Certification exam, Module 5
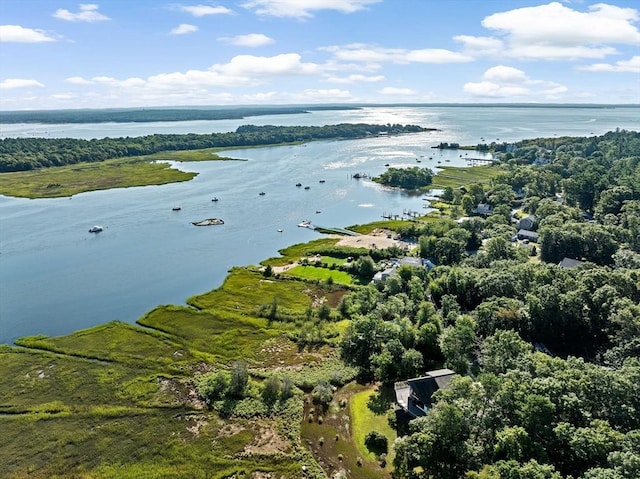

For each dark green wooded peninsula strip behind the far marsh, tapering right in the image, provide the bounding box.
[0,123,427,172]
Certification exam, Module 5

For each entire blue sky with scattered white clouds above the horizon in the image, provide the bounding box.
[0,0,640,110]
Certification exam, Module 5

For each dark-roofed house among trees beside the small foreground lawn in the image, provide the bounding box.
[394,369,456,420]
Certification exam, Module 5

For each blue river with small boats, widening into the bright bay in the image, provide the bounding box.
[0,107,640,343]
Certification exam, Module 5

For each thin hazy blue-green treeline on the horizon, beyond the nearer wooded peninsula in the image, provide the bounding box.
[0,106,356,124]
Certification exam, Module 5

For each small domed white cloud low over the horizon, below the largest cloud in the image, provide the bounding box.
[464,65,568,100]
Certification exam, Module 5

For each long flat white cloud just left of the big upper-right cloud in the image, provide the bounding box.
[321,43,473,65]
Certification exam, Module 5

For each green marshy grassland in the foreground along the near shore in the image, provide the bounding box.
[0,218,408,479]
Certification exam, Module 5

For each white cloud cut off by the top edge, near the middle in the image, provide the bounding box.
[242,0,382,19]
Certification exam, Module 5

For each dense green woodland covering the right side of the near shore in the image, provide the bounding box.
[339,131,640,479]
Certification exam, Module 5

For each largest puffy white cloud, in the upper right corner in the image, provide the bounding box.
[482,2,640,59]
